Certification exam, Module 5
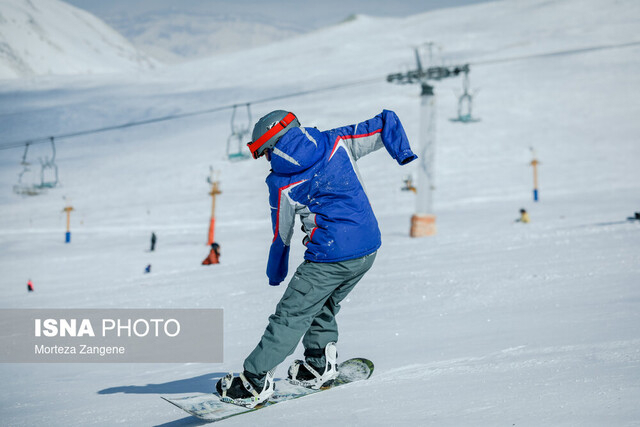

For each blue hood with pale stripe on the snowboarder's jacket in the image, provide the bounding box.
[271,127,324,175]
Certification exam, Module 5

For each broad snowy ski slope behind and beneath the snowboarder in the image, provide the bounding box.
[0,0,640,426]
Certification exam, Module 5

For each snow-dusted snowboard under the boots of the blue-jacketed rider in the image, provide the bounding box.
[162,358,373,422]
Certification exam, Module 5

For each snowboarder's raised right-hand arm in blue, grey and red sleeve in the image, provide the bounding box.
[327,110,418,165]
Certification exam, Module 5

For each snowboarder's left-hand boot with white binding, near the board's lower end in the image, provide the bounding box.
[216,369,275,408]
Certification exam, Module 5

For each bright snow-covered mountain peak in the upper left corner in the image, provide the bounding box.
[0,0,155,79]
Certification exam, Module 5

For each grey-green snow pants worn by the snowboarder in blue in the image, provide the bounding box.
[244,252,376,379]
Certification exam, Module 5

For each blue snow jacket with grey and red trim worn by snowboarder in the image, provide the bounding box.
[266,110,417,286]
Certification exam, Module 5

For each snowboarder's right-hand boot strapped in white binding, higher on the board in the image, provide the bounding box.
[288,342,338,390]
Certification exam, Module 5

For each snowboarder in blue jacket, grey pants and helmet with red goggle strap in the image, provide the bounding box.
[216,110,417,407]
